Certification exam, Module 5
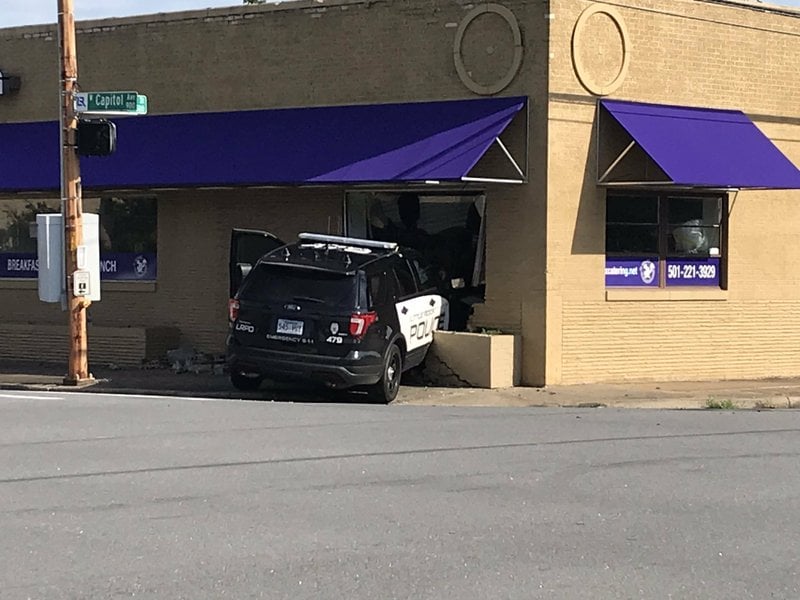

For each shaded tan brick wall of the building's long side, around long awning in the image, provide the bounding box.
[0,0,547,372]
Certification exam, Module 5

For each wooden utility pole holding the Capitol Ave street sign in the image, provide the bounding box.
[58,0,92,385]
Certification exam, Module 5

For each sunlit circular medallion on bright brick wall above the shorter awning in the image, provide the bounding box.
[572,4,631,96]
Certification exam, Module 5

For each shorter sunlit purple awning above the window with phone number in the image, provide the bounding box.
[600,100,800,189]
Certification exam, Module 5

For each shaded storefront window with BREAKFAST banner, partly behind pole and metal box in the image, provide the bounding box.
[0,197,158,281]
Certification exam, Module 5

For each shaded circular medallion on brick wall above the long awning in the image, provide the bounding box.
[453,4,522,96]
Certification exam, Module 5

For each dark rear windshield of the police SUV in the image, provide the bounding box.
[239,264,358,310]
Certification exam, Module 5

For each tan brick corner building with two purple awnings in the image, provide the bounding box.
[0,0,800,385]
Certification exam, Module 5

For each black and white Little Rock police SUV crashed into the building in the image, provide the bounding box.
[227,230,448,402]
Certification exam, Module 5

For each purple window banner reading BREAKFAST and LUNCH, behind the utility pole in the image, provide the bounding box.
[0,252,157,281]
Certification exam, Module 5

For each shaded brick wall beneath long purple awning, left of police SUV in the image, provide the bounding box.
[0,188,344,363]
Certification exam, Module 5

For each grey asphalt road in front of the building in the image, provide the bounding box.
[0,392,800,600]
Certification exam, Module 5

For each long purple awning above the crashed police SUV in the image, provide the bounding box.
[0,97,526,191]
